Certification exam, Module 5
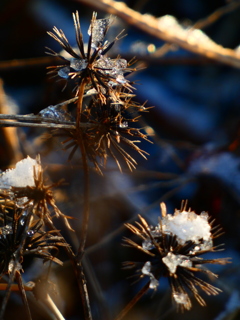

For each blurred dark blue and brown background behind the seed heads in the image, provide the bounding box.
[0,0,240,320]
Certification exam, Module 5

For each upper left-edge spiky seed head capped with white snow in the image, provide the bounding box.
[0,156,71,229]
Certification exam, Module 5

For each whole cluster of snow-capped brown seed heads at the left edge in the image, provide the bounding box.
[0,156,69,314]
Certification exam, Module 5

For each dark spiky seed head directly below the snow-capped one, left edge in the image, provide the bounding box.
[0,208,65,277]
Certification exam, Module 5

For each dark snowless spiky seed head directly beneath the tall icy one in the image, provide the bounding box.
[53,98,149,174]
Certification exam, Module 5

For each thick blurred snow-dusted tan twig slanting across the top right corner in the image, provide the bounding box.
[78,0,240,68]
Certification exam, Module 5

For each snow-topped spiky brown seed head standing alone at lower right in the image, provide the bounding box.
[124,205,229,311]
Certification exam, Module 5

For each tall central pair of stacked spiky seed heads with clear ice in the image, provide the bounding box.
[45,12,148,174]
